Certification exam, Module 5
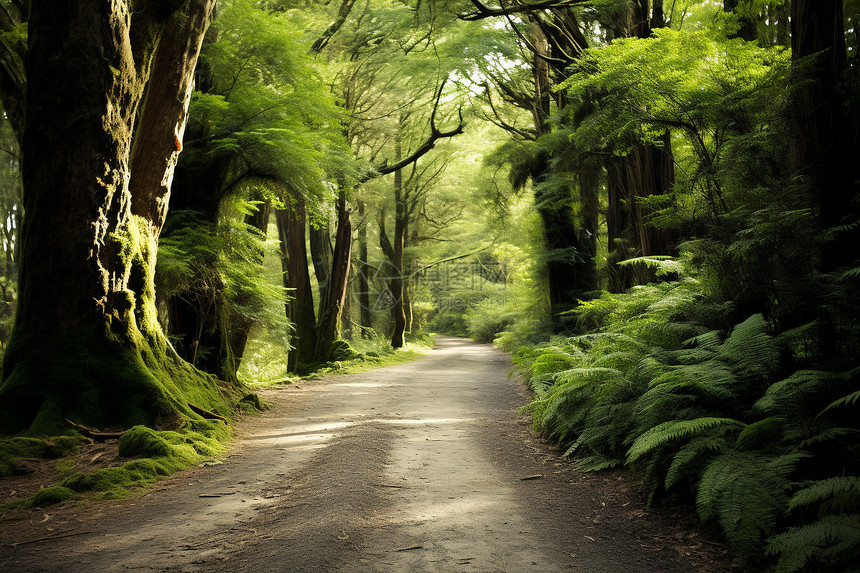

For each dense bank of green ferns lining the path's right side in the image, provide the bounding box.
[514,279,860,572]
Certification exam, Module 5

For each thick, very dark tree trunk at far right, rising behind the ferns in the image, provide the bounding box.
[781,0,860,358]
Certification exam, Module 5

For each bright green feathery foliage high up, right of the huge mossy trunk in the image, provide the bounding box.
[188,0,353,204]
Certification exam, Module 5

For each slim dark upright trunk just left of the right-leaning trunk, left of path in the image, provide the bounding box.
[275,197,316,372]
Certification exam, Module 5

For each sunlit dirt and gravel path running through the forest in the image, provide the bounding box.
[0,337,727,573]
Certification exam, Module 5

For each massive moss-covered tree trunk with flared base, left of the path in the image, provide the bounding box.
[0,0,226,433]
